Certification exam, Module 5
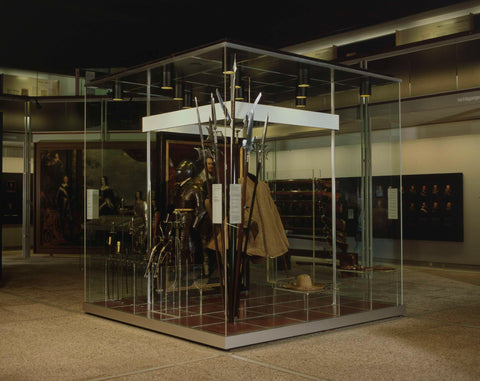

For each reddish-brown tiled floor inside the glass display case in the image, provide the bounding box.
[89,287,394,335]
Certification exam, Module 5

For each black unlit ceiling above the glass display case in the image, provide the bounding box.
[0,0,470,75]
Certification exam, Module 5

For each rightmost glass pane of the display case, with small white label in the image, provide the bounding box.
[335,78,402,309]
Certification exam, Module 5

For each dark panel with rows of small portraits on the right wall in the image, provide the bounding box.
[337,173,463,242]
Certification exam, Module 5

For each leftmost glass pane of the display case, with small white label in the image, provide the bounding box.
[85,96,148,314]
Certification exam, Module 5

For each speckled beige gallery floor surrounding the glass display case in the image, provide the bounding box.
[0,252,480,381]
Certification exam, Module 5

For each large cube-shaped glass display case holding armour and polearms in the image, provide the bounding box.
[84,41,405,349]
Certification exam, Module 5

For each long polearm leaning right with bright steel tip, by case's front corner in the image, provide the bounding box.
[232,93,262,316]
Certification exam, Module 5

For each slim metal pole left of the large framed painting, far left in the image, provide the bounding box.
[22,100,32,259]
